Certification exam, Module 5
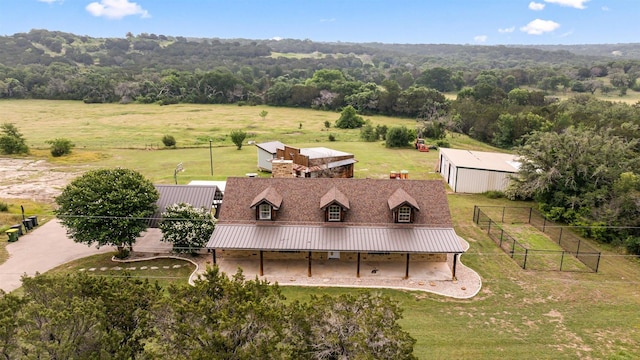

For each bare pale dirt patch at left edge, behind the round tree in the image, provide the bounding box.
[0,158,85,203]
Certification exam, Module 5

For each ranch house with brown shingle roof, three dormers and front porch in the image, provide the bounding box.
[206,178,464,279]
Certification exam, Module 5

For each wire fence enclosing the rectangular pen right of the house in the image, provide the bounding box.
[473,205,601,272]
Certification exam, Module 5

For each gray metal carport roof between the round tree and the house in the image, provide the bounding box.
[149,185,218,228]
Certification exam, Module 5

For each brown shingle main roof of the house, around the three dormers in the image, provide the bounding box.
[218,177,453,228]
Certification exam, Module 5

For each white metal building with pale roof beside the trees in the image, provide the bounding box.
[437,148,520,193]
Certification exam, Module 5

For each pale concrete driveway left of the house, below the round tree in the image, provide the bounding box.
[0,219,114,292]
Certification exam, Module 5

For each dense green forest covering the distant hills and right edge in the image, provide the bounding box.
[0,30,640,254]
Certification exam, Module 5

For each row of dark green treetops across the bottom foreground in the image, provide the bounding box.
[0,268,415,359]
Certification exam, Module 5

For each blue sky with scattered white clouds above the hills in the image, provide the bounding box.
[0,0,640,45]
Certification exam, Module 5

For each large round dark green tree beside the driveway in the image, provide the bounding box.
[56,168,159,250]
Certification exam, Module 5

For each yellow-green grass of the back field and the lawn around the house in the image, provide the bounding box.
[0,101,640,359]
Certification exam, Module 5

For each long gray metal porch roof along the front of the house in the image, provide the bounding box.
[206,224,464,253]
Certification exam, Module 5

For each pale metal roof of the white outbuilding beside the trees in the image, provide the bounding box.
[440,148,520,173]
